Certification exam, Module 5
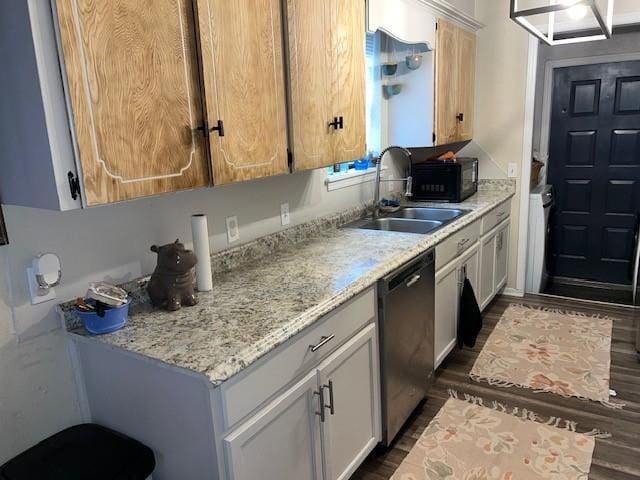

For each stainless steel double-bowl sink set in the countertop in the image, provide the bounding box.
[347,207,467,235]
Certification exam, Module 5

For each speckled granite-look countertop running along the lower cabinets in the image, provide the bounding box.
[61,182,514,385]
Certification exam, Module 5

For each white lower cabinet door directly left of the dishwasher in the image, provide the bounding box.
[318,324,380,480]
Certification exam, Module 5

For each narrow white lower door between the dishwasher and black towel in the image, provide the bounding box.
[434,261,460,368]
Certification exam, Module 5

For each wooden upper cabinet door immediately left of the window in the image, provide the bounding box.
[330,0,366,163]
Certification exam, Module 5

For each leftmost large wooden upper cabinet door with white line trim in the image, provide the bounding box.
[55,0,209,205]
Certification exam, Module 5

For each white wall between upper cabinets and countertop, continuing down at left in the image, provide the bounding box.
[0,165,394,463]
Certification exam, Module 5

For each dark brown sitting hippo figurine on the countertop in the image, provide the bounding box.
[147,240,198,312]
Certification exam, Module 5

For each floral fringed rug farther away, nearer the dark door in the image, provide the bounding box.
[469,305,621,408]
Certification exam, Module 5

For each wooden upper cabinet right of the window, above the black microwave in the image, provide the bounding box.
[435,19,476,145]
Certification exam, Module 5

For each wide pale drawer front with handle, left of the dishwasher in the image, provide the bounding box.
[221,288,375,429]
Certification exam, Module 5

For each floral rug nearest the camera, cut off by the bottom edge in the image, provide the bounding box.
[391,398,597,480]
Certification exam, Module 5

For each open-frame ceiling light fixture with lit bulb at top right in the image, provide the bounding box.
[510,0,614,45]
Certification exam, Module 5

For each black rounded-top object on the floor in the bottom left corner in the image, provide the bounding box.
[0,423,156,480]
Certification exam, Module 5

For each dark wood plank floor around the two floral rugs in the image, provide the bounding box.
[352,296,640,480]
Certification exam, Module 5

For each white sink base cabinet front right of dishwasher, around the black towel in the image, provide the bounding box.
[434,242,479,368]
